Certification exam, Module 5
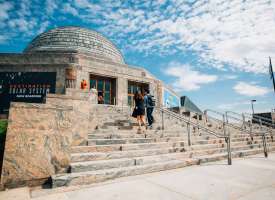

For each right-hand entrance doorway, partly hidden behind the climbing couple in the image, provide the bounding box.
[128,81,149,107]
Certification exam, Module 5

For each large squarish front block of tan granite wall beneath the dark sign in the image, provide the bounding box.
[1,103,73,187]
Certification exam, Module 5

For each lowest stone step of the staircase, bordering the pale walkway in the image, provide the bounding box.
[52,148,275,187]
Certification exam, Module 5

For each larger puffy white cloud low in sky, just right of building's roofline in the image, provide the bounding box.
[165,62,218,91]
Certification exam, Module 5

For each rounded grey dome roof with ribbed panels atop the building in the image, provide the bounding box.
[24,27,124,64]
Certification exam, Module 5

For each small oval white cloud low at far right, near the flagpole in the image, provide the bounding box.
[233,82,269,97]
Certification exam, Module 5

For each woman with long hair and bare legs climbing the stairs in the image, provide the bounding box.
[132,91,146,131]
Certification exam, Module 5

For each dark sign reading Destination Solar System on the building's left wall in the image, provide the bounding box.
[0,72,56,113]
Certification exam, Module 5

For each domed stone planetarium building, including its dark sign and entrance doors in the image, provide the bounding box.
[0,27,180,113]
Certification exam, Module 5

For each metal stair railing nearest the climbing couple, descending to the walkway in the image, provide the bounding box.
[155,107,232,165]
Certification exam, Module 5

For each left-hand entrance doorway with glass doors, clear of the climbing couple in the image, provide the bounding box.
[90,74,116,105]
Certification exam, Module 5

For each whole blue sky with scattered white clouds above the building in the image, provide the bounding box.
[0,0,275,112]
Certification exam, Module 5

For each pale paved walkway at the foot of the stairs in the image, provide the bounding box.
[0,153,275,200]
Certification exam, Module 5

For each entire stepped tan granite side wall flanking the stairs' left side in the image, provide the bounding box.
[0,89,139,187]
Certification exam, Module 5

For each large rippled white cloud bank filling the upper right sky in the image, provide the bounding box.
[68,0,275,73]
